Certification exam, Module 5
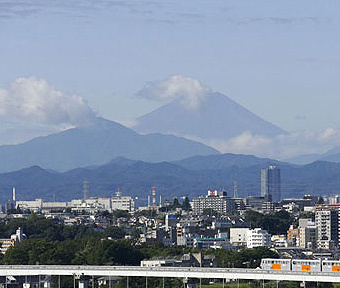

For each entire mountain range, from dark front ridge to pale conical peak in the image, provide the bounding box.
[0,84,340,204]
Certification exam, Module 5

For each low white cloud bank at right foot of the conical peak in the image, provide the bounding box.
[205,128,340,159]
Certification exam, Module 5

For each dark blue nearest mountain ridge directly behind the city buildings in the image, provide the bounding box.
[0,154,340,205]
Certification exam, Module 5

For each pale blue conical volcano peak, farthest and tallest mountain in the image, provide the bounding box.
[134,92,287,142]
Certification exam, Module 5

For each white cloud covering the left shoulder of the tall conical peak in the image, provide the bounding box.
[137,75,211,109]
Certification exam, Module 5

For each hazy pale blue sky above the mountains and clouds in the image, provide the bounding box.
[0,0,340,158]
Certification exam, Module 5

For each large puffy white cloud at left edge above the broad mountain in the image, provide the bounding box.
[0,77,95,127]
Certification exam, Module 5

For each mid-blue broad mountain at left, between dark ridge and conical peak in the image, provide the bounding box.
[0,118,219,172]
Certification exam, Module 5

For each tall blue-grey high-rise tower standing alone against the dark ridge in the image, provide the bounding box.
[261,166,281,202]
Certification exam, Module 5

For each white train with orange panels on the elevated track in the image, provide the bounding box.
[261,258,340,273]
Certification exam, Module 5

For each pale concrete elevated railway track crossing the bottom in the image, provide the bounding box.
[0,265,340,283]
